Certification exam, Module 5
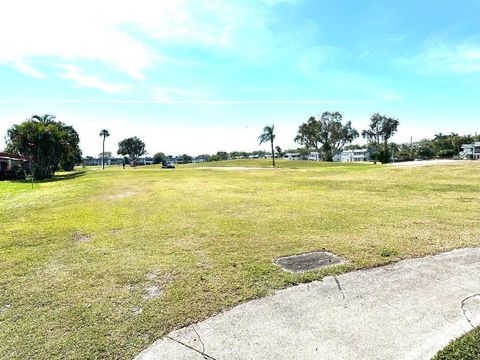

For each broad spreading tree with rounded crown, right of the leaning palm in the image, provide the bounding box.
[295,111,358,161]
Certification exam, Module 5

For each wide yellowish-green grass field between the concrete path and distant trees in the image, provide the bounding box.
[0,160,480,359]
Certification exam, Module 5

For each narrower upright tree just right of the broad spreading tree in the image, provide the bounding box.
[362,113,399,163]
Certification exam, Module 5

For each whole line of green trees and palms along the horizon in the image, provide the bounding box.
[2,111,480,179]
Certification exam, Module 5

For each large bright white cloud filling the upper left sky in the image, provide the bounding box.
[0,0,219,80]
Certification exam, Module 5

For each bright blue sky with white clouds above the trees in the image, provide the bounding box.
[0,0,480,155]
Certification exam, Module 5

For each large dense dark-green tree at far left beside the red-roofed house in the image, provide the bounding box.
[6,114,82,180]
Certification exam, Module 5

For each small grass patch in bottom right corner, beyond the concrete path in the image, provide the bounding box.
[433,327,480,360]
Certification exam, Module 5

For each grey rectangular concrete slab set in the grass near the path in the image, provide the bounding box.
[273,251,342,272]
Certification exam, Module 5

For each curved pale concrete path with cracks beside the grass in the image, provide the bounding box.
[137,249,480,360]
